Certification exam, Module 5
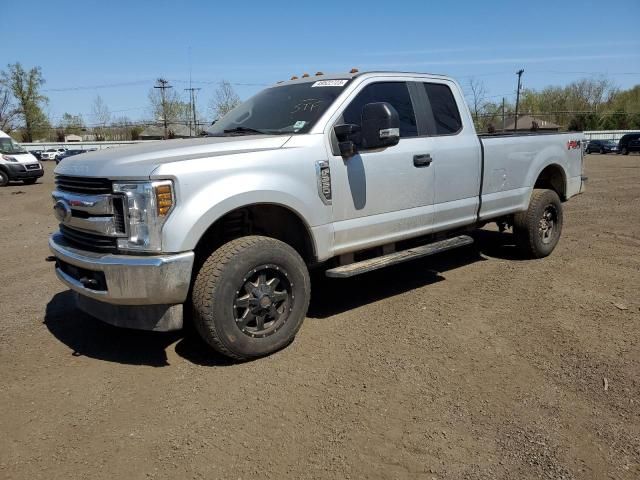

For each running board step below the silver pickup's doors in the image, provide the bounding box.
[325,235,473,278]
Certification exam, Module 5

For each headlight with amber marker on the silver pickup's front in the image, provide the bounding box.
[113,180,175,252]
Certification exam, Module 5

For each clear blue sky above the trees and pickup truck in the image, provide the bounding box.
[0,0,640,124]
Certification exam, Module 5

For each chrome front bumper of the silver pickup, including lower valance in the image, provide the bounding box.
[49,233,194,331]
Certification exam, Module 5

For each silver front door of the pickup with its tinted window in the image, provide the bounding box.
[330,79,435,254]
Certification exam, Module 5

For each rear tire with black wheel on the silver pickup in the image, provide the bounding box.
[513,188,562,258]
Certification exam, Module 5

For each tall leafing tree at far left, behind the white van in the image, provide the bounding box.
[0,62,50,142]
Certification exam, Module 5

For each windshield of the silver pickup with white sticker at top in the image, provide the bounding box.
[208,80,348,136]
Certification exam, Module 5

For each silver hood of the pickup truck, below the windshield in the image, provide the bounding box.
[55,135,291,179]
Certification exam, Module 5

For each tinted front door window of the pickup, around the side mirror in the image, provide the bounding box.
[342,82,418,138]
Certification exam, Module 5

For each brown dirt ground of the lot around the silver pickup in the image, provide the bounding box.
[0,155,640,480]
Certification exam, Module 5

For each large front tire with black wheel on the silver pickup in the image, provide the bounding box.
[192,236,311,360]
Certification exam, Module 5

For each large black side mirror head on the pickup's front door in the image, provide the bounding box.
[362,102,400,148]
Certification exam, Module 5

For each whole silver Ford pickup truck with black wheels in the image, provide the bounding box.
[49,72,585,360]
